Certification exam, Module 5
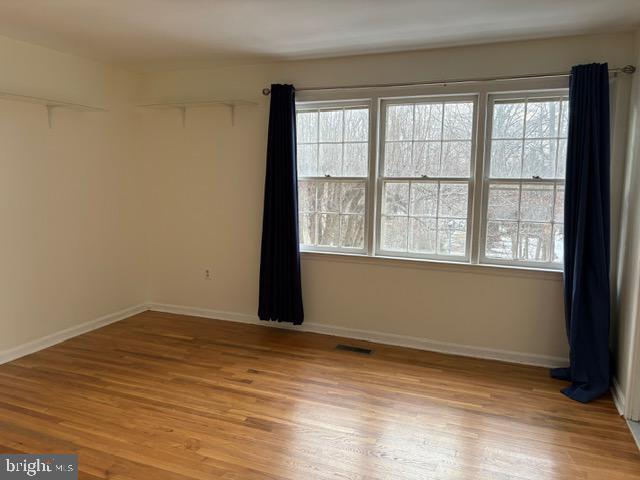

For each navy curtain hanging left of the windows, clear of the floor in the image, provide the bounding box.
[258,85,304,325]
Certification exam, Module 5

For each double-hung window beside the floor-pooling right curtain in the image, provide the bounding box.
[481,94,569,268]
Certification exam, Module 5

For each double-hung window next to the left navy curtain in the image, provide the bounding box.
[296,103,369,253]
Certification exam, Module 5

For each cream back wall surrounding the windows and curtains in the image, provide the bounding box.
[139,33,634,363]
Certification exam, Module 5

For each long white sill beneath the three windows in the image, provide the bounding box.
[300,250,562,282]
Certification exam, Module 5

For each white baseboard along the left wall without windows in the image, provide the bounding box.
[0,305,148,365]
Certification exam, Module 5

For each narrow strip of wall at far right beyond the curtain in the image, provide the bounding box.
[613,31,640,419]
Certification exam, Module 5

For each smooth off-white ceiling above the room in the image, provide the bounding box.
[0,0,640,69]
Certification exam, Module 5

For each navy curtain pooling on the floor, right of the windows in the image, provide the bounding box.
[551,64,610,403]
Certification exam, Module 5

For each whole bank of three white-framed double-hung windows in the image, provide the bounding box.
[297,86,568,269]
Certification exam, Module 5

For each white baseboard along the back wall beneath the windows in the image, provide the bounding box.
[148,303,568,367]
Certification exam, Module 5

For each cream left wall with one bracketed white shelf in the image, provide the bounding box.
[0,38,146,356]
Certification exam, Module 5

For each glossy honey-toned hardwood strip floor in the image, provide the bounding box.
[0,312,640,480]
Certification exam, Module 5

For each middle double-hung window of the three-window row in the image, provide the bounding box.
[378,97,475,259]
